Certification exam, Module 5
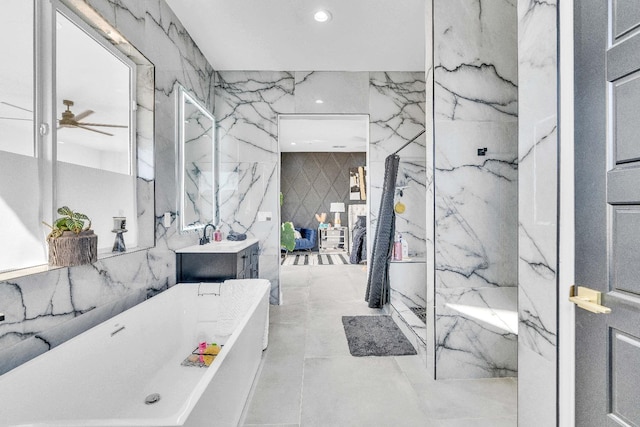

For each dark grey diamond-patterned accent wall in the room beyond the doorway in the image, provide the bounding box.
[280,153,367,229]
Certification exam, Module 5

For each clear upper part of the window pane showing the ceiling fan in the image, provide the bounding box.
[56,12,135,174]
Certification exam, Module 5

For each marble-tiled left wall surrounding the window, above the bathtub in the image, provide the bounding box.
[0,0,213,374]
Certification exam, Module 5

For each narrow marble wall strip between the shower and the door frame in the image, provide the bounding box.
[518,0,558,426]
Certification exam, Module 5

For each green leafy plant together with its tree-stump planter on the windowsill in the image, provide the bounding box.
[43,206,98,267]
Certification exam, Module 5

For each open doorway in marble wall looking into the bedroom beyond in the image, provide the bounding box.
[278,114,370,265]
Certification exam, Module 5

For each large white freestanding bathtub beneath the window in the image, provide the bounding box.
[0,279,270,427]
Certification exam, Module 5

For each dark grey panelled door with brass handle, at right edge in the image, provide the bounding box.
[574,0,640,427]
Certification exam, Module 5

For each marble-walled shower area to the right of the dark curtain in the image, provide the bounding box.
[384,0,519,379]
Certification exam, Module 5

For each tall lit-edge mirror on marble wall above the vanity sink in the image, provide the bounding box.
[177,86,216,232]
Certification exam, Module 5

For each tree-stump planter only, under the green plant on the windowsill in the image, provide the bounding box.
[47,230,98,267]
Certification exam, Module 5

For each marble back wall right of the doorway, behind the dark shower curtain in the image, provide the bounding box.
[367,72,427,318]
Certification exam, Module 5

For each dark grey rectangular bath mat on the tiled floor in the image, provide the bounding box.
[342,316,417,357]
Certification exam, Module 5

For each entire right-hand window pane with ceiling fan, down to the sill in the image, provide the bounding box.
[56,11,138,251]
